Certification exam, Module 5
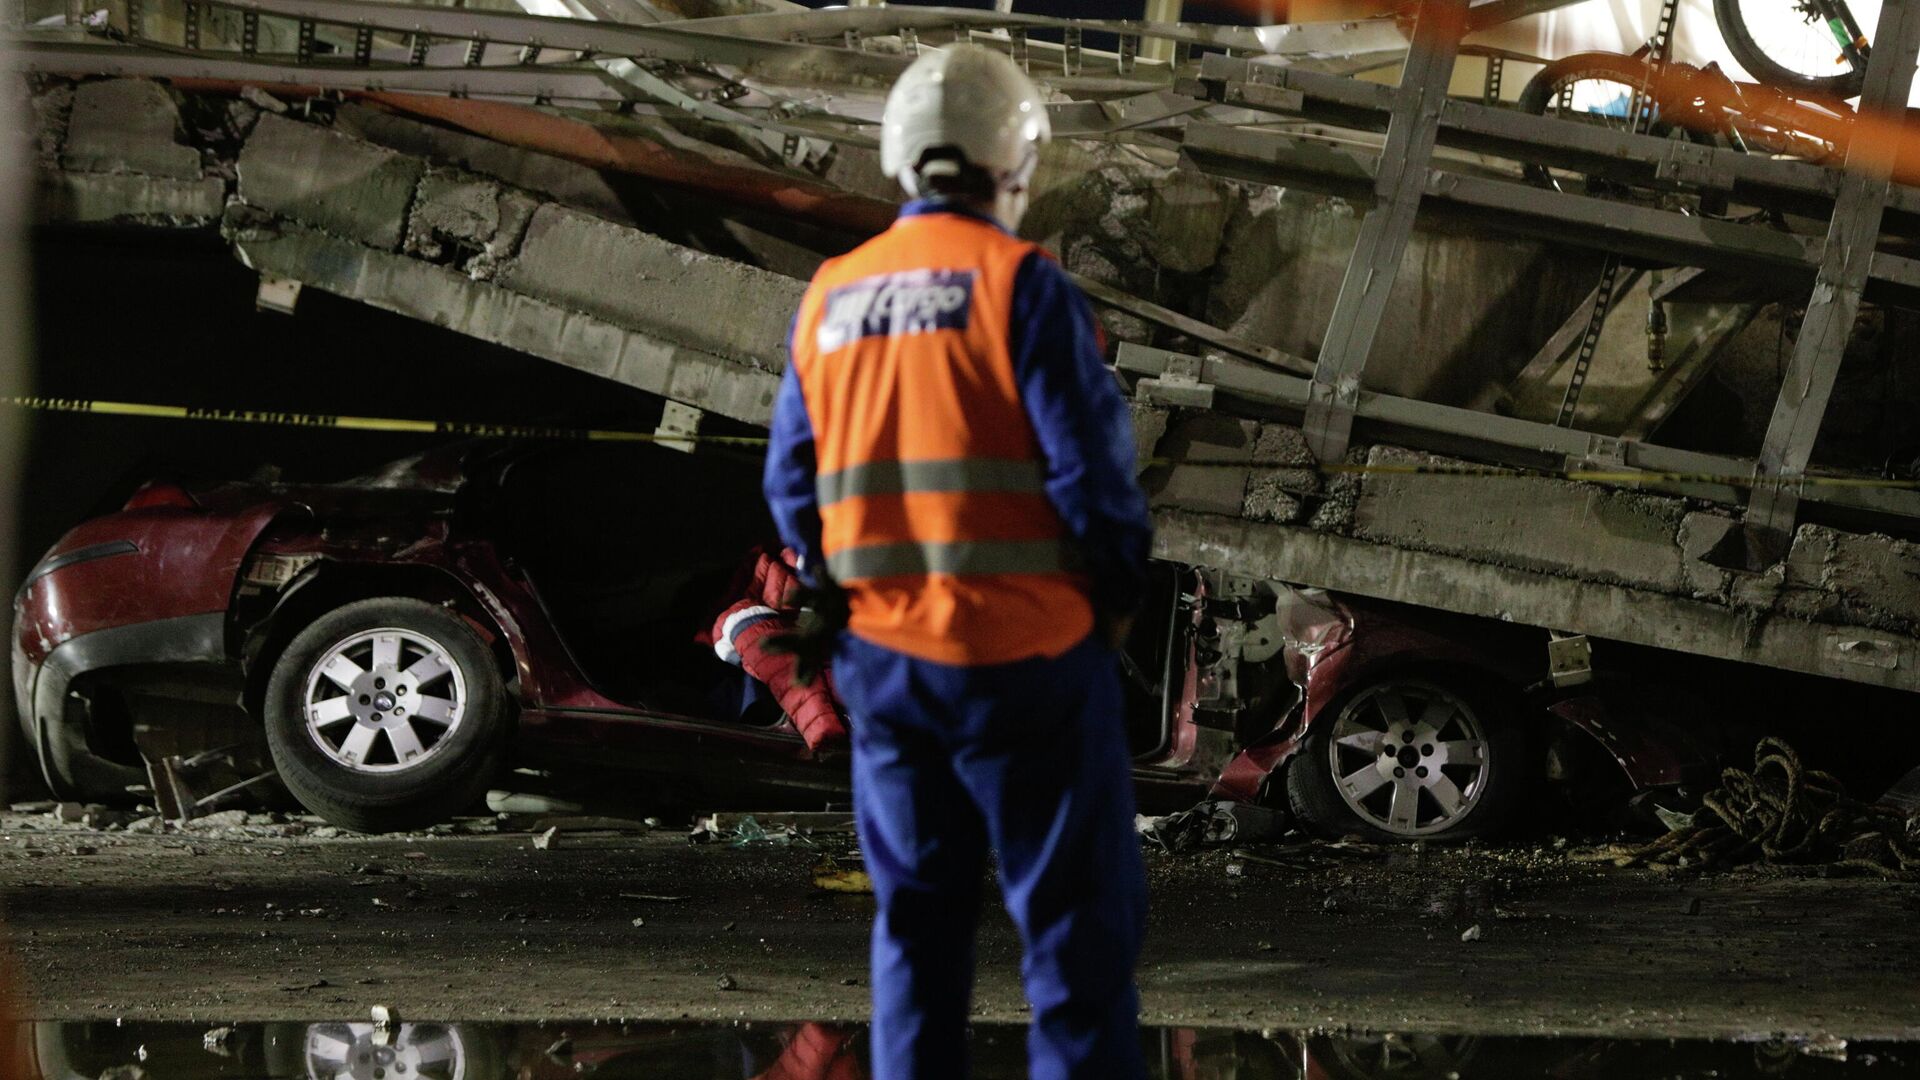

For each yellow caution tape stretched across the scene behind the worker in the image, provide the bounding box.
[0,398,1920,490]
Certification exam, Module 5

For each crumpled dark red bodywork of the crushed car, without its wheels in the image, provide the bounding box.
[13,444,1704,801]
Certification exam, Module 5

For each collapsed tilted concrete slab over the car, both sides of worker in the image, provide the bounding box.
[30,79,1920,690]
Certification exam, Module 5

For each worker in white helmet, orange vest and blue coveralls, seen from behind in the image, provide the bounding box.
[766,44,1150,1080]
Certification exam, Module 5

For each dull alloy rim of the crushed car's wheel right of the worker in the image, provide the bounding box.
[1327,680,1490,836]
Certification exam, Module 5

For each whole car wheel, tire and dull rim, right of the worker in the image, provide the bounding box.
[1286,676,1540,842]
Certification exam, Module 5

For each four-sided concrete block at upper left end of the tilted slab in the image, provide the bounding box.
[238,113,426,252]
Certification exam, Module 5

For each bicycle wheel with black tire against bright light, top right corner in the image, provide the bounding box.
[1713,0,1880,98]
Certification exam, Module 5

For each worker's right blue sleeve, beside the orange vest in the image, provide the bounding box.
[1008,252,1154,615]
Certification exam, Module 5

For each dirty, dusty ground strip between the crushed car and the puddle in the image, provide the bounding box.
[0,807,1920,1040]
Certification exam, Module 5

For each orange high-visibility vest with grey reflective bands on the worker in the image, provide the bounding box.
[793,213,1092,665]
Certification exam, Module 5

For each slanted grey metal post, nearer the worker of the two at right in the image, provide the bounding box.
[1306,0,1467,461]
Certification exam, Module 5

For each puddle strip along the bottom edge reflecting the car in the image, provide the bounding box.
[8,1020,1920,1080]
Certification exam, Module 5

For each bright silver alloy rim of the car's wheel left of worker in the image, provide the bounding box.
[301,626,467,773]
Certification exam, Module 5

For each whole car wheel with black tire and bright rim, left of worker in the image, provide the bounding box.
[263,598,513,832]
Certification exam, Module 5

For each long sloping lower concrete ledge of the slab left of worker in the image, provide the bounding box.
[228,227,780,427]
